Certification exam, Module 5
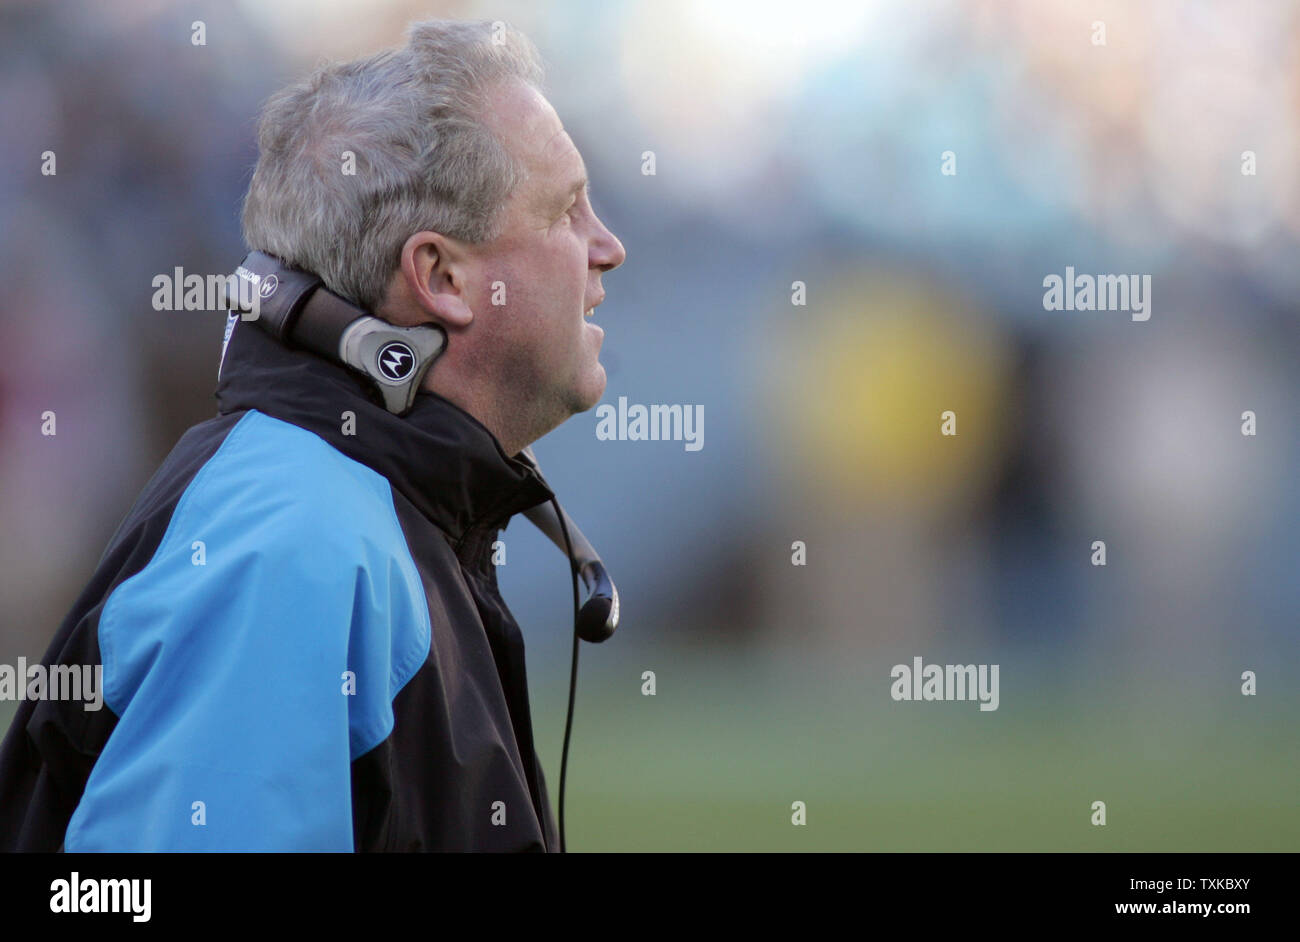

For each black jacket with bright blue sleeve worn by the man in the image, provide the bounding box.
[0,315,559,851]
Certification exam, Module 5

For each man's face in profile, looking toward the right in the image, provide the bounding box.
[468,83,627,427]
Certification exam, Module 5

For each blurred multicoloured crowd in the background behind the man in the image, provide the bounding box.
[0,0,1300,661]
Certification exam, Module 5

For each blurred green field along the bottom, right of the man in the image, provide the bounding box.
[0,647,1300,851]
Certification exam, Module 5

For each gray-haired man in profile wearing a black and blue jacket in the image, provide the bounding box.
[0,22,624,851]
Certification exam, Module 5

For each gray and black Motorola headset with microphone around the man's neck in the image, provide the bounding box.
[226,252,619,852]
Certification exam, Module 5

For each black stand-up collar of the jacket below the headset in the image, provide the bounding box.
[216,321,554,543]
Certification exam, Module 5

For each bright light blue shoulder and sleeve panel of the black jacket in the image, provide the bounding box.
[65,412,430,851]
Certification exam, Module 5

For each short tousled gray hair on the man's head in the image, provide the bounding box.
[243,19,543,311]
